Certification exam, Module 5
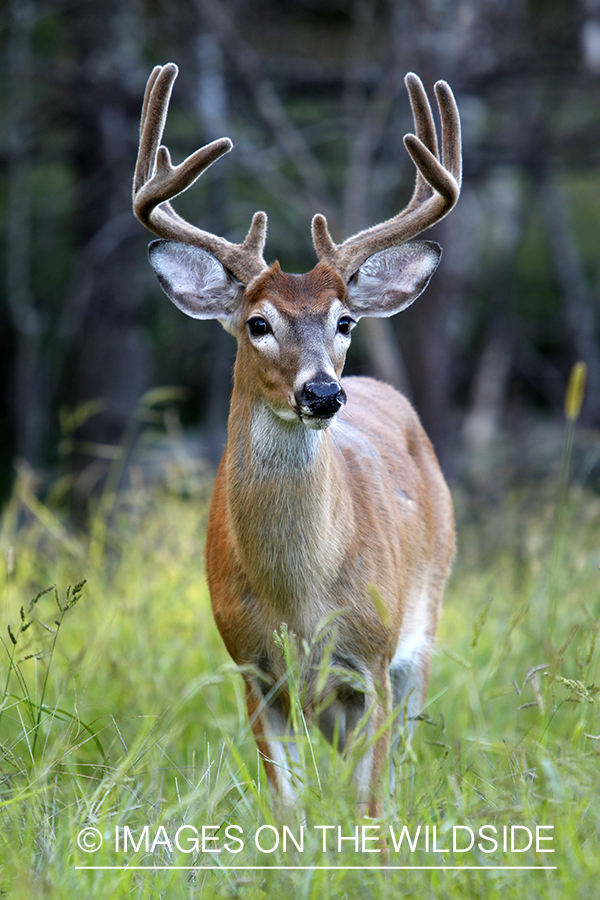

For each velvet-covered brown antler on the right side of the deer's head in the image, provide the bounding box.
[312,72,462,279]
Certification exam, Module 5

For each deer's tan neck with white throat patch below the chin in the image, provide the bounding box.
[227,387,351,608]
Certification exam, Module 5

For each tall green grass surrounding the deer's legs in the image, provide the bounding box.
[0,440,600,900]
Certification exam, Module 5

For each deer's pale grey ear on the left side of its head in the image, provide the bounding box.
[148,240,244,334]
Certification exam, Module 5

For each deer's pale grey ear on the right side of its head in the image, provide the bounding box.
[346,241,442,316]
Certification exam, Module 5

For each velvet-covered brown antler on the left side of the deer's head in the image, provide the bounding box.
[133,63,267,284]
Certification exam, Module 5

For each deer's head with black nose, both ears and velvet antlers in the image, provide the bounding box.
[133,63,461,428]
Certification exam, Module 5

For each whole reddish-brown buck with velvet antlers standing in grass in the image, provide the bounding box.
[133,64,461,815]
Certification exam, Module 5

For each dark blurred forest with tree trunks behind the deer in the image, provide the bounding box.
[0,0,600,503]
